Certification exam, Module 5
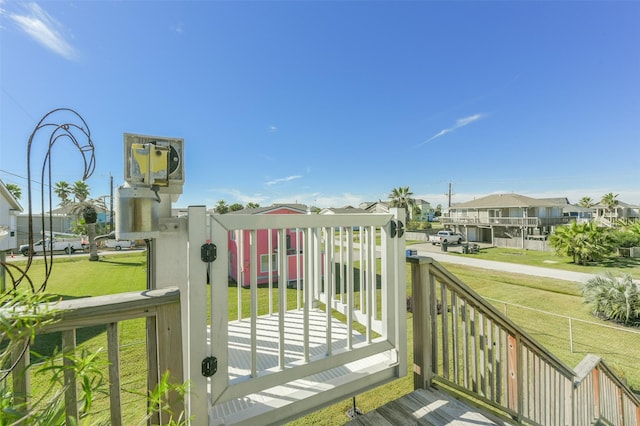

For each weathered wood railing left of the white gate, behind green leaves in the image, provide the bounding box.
[6,288,184,425]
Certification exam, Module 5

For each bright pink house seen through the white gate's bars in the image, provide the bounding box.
[227,204,307,287]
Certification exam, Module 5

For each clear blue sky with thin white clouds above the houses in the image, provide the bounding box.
[0,0,640,211]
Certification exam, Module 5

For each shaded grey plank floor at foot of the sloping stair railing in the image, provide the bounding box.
[347,388,511,426]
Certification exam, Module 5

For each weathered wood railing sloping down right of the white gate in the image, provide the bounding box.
[408,257,640,425]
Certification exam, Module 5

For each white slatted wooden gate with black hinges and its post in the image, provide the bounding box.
[185,207,407,425]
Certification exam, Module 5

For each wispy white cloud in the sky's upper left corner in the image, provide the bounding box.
[9,3,77,59]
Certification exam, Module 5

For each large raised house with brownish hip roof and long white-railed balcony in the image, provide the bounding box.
[441,194,571,245]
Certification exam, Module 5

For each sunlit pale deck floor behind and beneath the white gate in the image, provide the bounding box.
[209,310,394,425]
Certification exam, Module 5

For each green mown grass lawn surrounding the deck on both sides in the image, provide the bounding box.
[8,252,640,425]
